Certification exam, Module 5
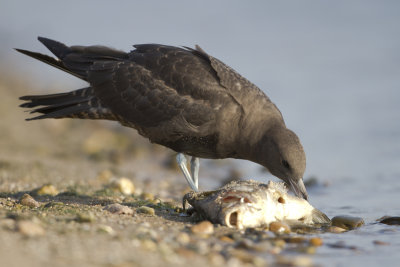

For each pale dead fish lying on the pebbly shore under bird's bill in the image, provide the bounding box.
[183,180,330,229]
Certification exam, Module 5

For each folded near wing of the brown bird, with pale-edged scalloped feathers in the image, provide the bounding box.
[88,61,222,135]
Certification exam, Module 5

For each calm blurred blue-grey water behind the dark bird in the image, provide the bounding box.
[0,0,400,266]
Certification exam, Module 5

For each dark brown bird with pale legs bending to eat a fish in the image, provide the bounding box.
[16,37,308,199]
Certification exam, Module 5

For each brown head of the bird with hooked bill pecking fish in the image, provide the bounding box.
[259,126,308,199]
